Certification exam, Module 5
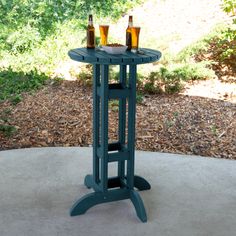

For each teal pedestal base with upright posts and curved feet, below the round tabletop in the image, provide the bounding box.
[70,65,151,222]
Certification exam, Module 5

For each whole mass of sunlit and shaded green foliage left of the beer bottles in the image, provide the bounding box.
[0,0,142,101]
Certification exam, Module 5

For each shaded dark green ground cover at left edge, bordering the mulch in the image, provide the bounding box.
[0,68,48,101]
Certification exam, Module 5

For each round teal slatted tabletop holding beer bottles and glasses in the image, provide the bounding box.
[68,48,161,65]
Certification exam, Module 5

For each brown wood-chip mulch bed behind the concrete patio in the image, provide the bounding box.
[0,81,236,159]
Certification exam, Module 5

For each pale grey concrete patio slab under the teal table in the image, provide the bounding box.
[0,148,236,236]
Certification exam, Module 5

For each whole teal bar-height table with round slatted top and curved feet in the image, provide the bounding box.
[68,48,161,222]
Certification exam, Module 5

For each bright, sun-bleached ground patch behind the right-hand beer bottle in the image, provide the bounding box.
[110,0,229,53]
